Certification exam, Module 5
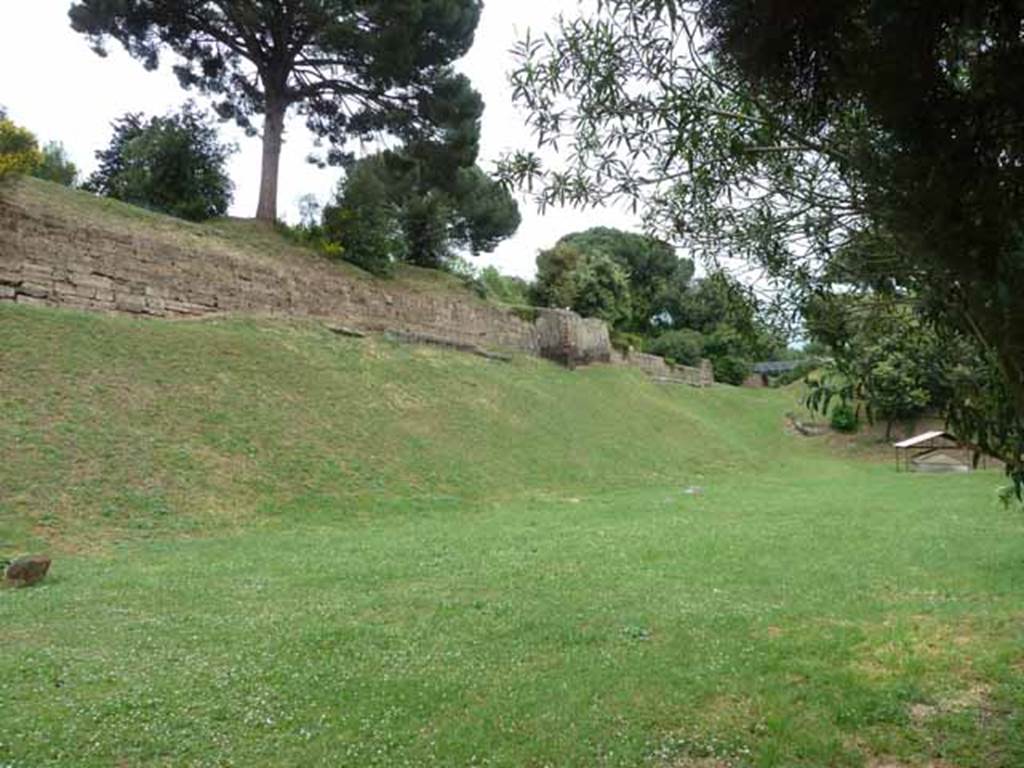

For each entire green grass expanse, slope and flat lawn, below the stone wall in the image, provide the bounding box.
[0,306,1024,768]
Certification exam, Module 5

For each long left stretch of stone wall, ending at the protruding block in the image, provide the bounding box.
[0,196,541,354]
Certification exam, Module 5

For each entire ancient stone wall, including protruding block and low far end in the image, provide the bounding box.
[0,186,713,386]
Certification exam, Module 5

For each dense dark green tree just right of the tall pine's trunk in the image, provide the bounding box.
[324,77,520,272]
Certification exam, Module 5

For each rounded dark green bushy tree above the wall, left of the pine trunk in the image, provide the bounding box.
[83,103,233,221]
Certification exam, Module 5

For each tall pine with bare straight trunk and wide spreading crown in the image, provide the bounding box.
[70,0,481,221]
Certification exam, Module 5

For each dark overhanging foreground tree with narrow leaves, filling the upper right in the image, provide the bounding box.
[503,0,1024,479]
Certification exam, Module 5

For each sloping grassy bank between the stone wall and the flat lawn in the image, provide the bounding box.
[0,305,782,548]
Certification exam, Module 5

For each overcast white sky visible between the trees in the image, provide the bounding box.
[0,0,640,276]
